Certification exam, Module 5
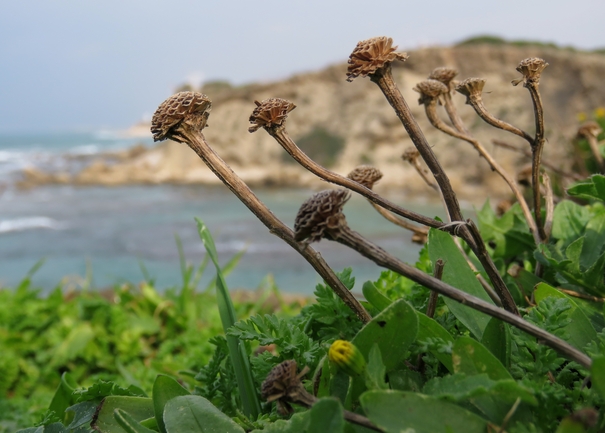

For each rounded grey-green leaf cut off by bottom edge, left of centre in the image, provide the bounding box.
[164,395,244,433]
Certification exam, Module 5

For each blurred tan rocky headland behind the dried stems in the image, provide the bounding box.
[20,44,605,202]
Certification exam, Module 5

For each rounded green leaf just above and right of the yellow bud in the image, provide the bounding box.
[352,299,418,372]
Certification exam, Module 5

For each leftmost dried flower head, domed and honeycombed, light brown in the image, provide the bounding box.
[151,92,212,141]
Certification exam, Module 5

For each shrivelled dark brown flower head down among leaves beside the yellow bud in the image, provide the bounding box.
[261,359,312,413]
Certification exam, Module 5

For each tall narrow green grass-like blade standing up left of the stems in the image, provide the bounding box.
[195,218,261,418]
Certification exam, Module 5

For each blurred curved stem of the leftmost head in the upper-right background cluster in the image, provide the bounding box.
[424,99,541,245]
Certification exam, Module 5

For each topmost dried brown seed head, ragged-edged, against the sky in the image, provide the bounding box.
[347,36,408,81]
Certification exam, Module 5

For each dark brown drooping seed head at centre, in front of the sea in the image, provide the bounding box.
[294,189,351,243]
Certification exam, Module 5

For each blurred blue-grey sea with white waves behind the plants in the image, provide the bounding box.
[0,131,443,295]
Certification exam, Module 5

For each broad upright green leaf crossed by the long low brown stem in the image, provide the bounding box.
[428,229,493,339]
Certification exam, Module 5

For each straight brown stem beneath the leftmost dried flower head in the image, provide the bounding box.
[174,123,372,323]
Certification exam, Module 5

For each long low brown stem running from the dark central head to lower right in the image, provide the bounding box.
[324,225,592,369]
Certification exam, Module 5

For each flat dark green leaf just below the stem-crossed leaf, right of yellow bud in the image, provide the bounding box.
[452,336,512,380]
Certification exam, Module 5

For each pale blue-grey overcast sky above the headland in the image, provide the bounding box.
[0,0,605,132]
